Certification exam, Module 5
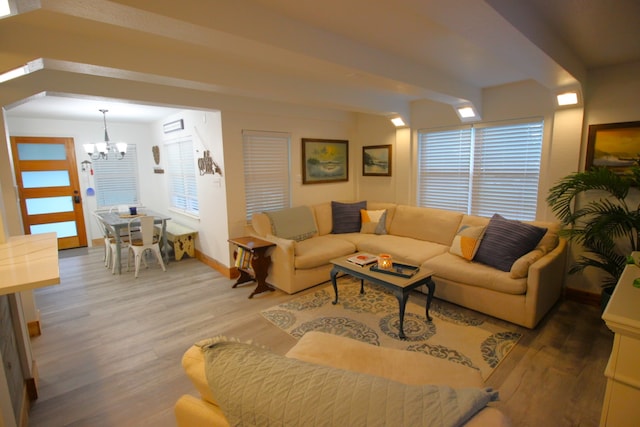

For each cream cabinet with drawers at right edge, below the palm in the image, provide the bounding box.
[600,260,640,427]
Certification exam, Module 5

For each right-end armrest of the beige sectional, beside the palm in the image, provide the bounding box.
[525,239,567,328]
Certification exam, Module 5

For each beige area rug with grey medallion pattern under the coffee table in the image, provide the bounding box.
[261,276,521,380]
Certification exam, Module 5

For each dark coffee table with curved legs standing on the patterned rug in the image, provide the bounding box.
[331,254,436,339]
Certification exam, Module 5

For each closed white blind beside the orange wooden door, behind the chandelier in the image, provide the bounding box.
[93,144,139,208]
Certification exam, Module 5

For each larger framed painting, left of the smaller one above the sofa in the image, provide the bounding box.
[302,138,349,184]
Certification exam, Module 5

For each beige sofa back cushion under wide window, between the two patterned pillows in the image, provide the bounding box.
[387,205,463,246]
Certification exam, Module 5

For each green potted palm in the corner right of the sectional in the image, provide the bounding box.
[547,165,640,305]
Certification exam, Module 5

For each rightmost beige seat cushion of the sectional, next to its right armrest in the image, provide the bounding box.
[422,252,527,296]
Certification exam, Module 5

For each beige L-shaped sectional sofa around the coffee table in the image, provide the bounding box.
[250,201,567,328]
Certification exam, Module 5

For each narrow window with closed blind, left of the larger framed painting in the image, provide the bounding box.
[242,131,291,221]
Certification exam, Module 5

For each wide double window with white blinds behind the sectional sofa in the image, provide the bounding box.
[417,121,543,220]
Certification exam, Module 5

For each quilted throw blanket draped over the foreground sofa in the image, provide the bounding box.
[203,338,498,427]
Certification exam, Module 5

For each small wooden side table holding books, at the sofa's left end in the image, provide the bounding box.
[229,236,276,298]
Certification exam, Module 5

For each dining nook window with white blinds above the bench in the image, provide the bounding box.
[165,138,200,216]
